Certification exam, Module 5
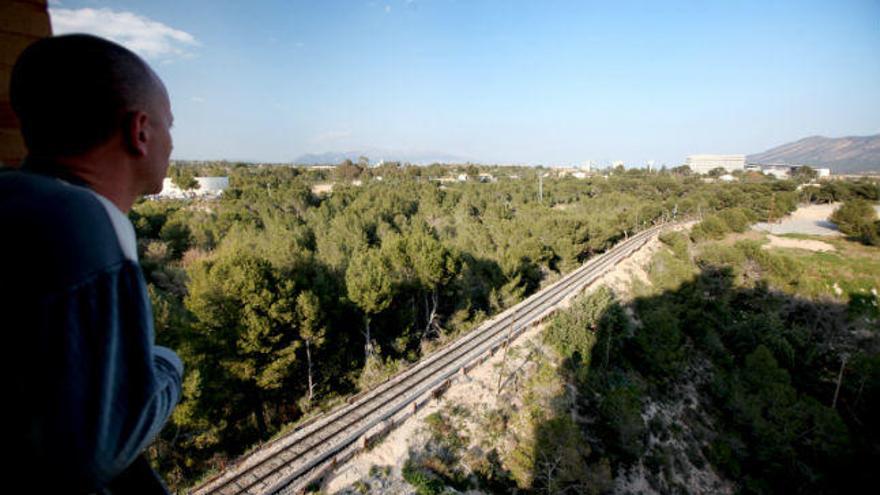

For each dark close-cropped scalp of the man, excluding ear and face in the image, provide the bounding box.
[9,34,164,158]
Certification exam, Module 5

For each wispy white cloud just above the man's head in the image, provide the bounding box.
[49,8,199,61]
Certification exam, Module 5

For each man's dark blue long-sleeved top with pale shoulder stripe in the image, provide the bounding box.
[0,168,183,493]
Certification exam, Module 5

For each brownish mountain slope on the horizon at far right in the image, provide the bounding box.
[747,134,880,173]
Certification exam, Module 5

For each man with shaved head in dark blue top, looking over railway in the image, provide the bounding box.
[0,35,183,493]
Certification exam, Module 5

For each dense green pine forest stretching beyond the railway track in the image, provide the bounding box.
[130,163,880,489]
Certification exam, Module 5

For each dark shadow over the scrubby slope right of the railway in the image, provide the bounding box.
[532,266,880,493]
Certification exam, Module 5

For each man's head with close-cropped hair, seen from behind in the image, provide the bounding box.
[10,34,173,198]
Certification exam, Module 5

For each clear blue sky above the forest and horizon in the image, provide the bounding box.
[50,0,880,165]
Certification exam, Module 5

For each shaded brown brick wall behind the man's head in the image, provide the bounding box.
[0,0,52,166]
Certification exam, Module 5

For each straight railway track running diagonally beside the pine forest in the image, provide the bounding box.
[192,224,669,495]
